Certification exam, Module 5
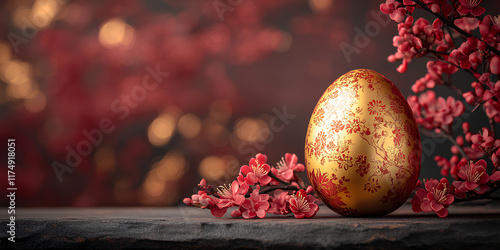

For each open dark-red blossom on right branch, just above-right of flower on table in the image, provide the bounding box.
[453,160,490,194]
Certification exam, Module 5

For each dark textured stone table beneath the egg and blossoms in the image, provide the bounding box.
[0,202,500,249]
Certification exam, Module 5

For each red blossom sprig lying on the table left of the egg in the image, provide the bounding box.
[184,153,319,219]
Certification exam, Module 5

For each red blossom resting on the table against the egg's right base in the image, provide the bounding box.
[411,178,455,218]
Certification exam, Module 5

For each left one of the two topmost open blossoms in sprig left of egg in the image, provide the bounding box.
[240,154,272,186]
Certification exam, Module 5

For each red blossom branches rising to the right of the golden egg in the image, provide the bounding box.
[380,0,500,217]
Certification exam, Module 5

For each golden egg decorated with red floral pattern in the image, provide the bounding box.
[305,69,422,216]
